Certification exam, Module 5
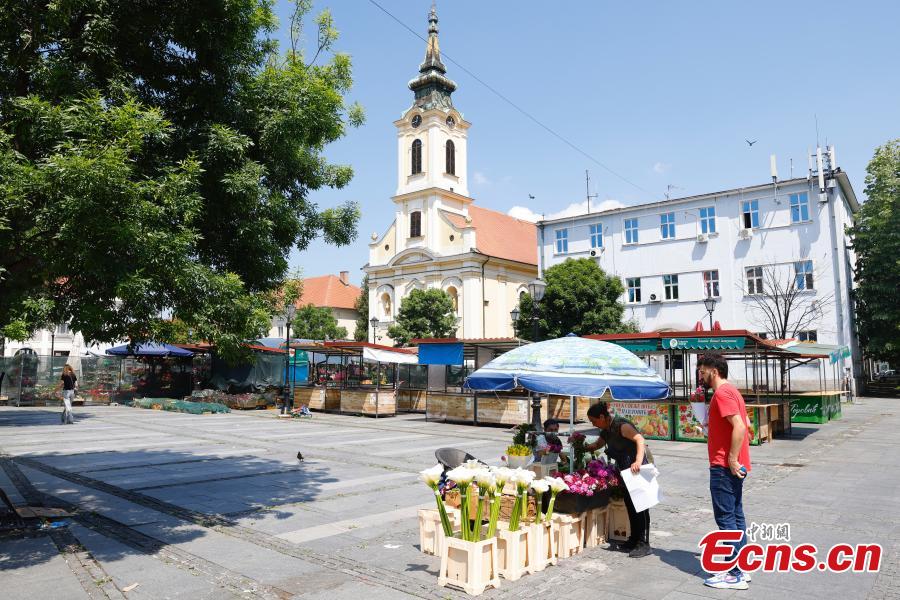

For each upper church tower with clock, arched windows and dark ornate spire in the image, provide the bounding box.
[394,5,470,196]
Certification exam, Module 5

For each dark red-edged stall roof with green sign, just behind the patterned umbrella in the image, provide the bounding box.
[584,329,784,354]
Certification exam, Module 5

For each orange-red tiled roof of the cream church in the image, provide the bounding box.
[441,204,537,265]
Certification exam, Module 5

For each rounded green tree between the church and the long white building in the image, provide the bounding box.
[516,258,636,340]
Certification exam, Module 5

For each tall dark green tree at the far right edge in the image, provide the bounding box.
[849,139,900,366]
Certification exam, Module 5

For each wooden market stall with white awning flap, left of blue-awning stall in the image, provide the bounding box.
[291,342,418,417]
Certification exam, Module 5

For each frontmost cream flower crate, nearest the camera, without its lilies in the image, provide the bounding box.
[438,537,500,596]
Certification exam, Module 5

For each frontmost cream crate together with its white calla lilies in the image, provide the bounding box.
[438,461,500,596]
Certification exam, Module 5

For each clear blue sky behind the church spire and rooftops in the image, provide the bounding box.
[276,0,900,283]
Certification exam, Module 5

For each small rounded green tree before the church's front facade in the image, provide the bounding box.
[388,289,456,346]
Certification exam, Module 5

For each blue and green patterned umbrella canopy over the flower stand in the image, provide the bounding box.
[465,336,669,400]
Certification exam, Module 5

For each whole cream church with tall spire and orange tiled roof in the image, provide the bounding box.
[363,7,537,344]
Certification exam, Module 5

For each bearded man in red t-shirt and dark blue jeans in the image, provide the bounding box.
[697,354,750,590]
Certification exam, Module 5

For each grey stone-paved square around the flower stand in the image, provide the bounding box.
[0,398,900,600]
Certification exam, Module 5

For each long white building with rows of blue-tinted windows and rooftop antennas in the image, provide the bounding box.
[538,148,862,386]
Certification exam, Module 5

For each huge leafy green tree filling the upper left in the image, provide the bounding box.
[0,0,362,360]
